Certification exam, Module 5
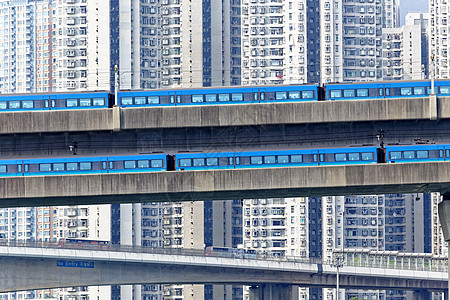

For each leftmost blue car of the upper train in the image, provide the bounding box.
[0,92,113,112]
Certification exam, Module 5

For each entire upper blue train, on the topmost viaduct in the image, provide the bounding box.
[0,80,444,111]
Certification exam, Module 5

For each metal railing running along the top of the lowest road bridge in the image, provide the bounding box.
[0,239,448,272]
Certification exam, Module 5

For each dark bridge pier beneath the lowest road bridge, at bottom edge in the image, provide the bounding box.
[249,283,298,300]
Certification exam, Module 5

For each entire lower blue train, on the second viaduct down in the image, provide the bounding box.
[0,144,450,177]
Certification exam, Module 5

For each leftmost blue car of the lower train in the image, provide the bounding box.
[0,154,166,177]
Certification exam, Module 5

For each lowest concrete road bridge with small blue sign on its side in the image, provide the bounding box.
[0,244,447,292]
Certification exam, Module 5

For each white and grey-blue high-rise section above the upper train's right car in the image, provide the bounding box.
[320,0,399,83]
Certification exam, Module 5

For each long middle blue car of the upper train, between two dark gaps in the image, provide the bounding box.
[118,84,319,107]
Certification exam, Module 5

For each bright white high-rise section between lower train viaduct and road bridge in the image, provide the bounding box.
[242,197,321,299]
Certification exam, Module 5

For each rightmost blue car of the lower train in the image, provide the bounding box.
[386,144,450,163]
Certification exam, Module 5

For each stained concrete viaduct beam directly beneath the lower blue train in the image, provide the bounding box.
[0,162,450,207]
